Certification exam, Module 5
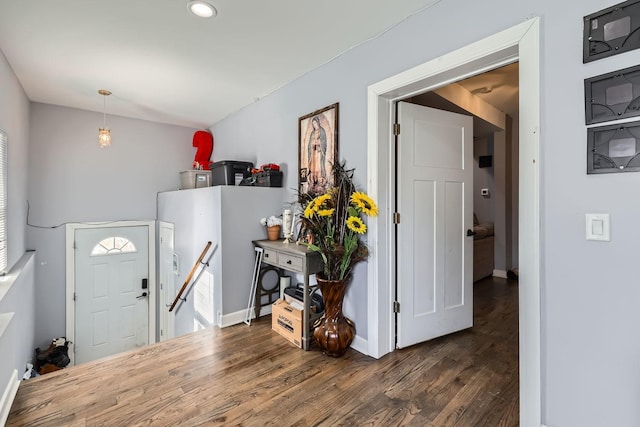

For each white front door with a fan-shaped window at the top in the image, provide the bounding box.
[74,226,150,363]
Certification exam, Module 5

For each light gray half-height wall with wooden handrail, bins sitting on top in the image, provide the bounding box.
[158,185,284,336]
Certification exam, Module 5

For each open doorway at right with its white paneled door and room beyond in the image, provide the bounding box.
[394,62,519,348]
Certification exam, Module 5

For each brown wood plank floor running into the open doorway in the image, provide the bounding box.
[7,279,518,427]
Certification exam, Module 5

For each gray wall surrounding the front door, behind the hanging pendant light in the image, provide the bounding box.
[27,103,195,343]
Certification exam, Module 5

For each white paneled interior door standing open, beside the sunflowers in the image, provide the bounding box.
[397,102,473,348]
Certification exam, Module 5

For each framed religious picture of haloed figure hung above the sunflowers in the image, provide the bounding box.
[298,103,338,195]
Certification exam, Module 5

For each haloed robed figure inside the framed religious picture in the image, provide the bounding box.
[305,114,333,194]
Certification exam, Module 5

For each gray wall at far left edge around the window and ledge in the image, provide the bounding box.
[0,52,35,394]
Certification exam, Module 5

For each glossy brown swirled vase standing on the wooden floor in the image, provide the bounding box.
[313,276,356,357]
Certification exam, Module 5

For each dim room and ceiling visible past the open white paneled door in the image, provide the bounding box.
[402,62,519,282]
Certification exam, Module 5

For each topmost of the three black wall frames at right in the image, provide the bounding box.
[583,0,640,63]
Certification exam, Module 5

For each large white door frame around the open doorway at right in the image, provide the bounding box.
[367,17,542,427]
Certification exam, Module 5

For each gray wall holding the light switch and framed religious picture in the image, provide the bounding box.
[212,0,640,427]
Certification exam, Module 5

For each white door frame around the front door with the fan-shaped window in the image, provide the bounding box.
[65,221,157,366]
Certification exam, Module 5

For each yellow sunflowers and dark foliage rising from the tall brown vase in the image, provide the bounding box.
[301,163,378,280]
